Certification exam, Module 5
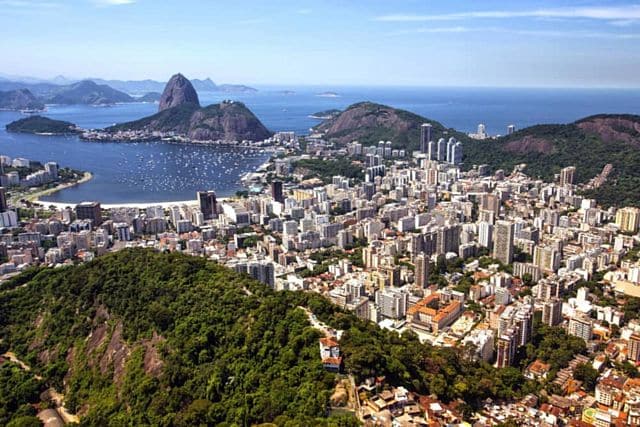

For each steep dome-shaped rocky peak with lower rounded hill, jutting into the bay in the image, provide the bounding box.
[106,74,271,141]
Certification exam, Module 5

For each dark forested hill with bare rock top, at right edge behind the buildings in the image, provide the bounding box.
[464,114,640,206]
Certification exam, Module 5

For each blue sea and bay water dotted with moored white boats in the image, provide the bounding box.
[0,86,640,204]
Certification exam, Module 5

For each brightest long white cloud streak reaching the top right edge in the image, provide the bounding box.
[374,4,640,22]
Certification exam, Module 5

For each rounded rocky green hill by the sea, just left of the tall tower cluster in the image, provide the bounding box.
[314,102,467,151]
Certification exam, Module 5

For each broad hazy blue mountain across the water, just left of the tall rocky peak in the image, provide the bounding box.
[45,80,135,105]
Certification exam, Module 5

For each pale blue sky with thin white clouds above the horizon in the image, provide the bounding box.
[0,0,640,88]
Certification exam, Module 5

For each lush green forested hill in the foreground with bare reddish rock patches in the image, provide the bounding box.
[0,249,524,426]
